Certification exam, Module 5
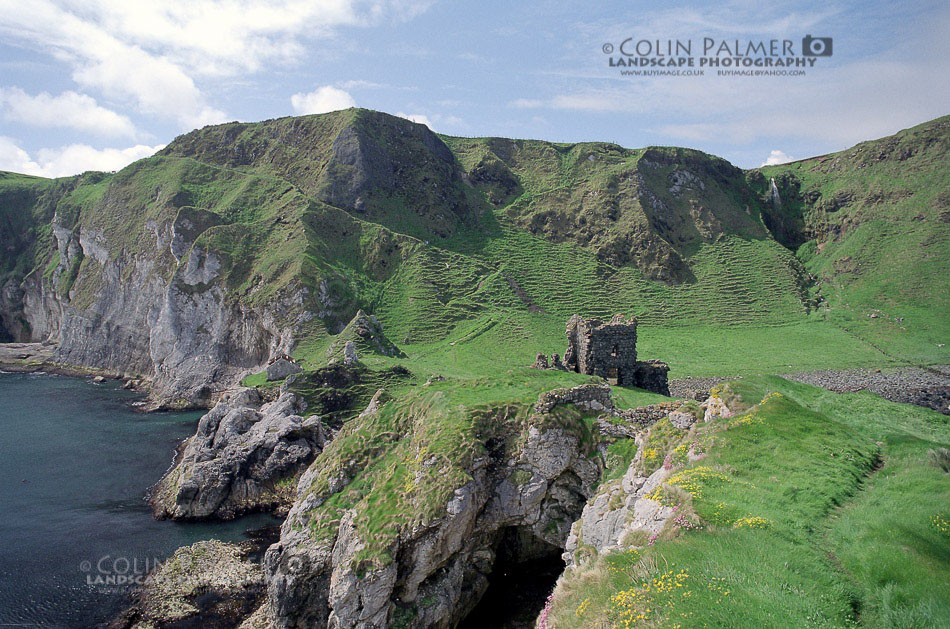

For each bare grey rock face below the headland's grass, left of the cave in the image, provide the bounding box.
[265,390,609,628]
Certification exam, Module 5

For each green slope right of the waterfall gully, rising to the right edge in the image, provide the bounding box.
[759,117,950,364]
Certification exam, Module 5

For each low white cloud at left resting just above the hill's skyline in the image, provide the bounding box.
[0,136,165,177]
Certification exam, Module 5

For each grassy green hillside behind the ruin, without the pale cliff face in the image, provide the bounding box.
[0,110,950,377]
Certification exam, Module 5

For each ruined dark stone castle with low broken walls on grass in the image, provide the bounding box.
[533,314,670,395]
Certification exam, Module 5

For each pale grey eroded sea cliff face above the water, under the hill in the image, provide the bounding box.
[10,206,313,408]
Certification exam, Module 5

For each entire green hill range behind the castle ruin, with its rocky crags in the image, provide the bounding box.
[0,109,950,392]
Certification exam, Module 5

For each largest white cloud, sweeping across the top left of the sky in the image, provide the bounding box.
[0,0,431,128]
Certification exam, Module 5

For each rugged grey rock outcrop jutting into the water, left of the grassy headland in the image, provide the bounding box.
[151,388,325,519]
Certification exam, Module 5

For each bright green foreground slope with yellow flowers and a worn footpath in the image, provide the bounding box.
[552,377,950,628]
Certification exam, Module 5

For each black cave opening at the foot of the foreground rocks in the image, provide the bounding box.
[458,527,564,629]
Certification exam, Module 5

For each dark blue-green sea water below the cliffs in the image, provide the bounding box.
[0,373,276,627]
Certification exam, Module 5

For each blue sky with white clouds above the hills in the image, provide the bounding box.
[0,0,950,177]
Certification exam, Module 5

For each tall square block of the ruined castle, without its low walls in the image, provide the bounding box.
[564,314,637,385]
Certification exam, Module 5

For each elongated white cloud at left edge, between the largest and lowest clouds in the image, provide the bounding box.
[0,87,135,137]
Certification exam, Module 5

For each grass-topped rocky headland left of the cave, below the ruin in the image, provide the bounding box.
[265,385,609,627]
